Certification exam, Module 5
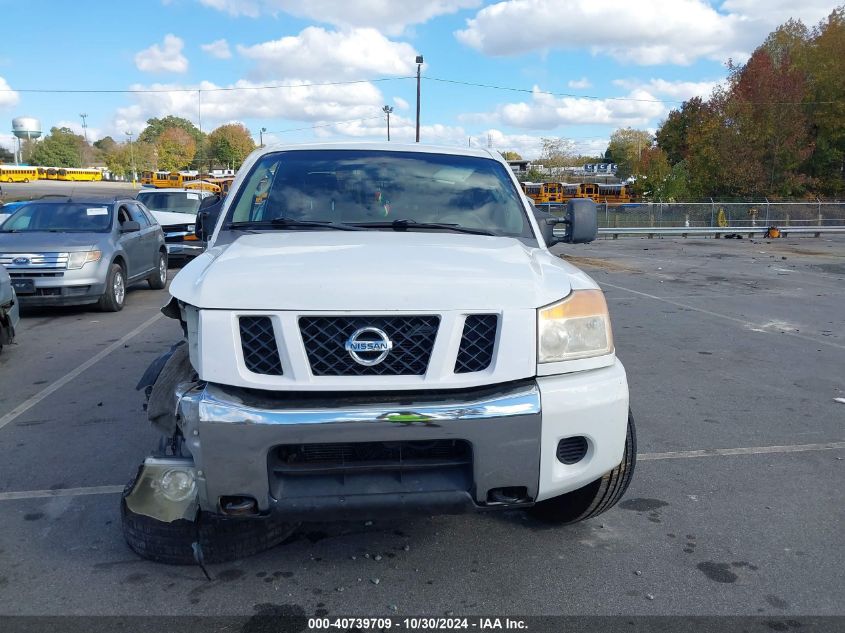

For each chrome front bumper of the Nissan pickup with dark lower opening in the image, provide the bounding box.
[179,381,541,520]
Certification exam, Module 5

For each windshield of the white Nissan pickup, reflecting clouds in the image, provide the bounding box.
[226,150,534,238]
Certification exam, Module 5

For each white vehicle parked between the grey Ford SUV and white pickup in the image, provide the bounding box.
[136,188,219,262]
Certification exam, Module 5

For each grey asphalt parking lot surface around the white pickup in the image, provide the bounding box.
[0,238,845,630]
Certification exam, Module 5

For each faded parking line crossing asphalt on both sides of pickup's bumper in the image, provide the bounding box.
[0,442,845,501]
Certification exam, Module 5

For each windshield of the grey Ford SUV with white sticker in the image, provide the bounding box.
[0,202,112,233]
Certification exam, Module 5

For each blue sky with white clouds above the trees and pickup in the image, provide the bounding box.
[0,0,837,158]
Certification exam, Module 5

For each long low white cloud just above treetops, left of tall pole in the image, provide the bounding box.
[114,79,392,133]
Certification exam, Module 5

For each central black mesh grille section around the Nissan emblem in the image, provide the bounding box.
[299,316,440,376]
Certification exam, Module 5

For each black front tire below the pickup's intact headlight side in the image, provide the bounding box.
[529,411,637,525]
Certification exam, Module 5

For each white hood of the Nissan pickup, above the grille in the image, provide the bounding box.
[170,231,596,311]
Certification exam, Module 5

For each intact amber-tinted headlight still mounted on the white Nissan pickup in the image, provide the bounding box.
[537,290,613,363]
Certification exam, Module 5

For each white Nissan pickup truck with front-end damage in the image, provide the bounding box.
[122,143,636,563]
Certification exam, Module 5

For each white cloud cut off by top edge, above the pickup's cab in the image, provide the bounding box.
[195,0,481,35]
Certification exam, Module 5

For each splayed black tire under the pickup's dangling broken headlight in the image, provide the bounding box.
[120,474,299,565]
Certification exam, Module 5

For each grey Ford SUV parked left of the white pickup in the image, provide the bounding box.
[0,198,167,312]
